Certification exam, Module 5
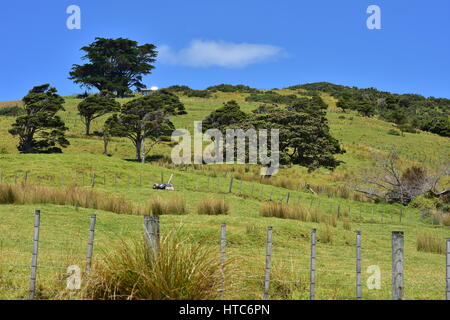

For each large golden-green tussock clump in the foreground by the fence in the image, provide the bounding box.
[80,235,223,300]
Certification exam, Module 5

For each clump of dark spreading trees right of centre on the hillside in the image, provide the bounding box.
[203,97,345,171]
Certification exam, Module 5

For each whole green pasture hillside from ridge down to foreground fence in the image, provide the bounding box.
[0,84,450,299]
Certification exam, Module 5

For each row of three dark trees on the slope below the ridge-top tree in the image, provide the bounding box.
[9,84,186,161]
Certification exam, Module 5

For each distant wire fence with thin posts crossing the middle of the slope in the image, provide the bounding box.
[0,170,440,225]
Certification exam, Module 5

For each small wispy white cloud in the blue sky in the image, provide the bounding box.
[159,40,282,68]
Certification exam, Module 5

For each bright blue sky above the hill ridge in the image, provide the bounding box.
[0,0,450,101]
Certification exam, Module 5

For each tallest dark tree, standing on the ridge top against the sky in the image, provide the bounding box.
[69,38,158,97]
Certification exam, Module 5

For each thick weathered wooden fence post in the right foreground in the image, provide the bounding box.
[392,231,404,300]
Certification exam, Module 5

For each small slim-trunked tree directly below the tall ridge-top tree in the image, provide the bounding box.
[78,95,120,136]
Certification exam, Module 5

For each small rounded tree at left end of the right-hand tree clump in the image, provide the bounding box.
[203,100,247,131]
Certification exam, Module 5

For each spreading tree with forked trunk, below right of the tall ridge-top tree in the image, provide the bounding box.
[110,90,186,161]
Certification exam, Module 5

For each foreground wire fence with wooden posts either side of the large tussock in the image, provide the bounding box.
[0,211,450,300]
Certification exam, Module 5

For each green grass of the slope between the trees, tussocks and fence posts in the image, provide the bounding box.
[0,93,450,299]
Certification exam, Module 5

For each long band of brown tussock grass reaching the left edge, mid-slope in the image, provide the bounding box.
[0,183,142,214]
